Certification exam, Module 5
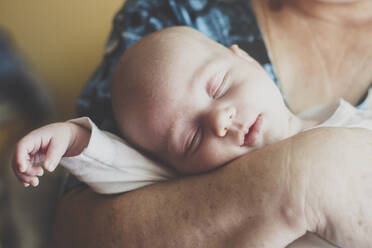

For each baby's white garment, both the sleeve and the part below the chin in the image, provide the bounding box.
[61,99,372,194]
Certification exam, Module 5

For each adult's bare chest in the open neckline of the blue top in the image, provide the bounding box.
[256,0,372,113]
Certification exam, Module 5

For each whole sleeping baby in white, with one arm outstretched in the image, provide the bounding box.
[10,27,372,194]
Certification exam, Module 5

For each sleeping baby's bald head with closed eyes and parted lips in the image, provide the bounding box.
[113,26,293,174]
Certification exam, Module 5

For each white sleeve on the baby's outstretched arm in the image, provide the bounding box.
[61,117,176,194]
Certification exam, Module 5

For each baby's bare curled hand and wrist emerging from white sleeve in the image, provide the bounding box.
[13,122,90,187]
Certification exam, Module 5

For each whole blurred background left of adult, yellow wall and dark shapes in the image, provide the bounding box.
[0,0,124,248]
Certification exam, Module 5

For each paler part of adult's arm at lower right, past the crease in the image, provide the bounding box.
[294,128,372,248]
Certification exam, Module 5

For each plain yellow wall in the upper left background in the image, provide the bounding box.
[0,0,124,120]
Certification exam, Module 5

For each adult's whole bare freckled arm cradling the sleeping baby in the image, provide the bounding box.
[51,128,372,248]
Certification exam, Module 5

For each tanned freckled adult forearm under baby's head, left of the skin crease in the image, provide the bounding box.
[52,140,306,248]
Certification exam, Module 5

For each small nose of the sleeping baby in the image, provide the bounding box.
[209,107,236,137]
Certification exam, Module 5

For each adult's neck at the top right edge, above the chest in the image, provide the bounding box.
[286,0,372,26]
